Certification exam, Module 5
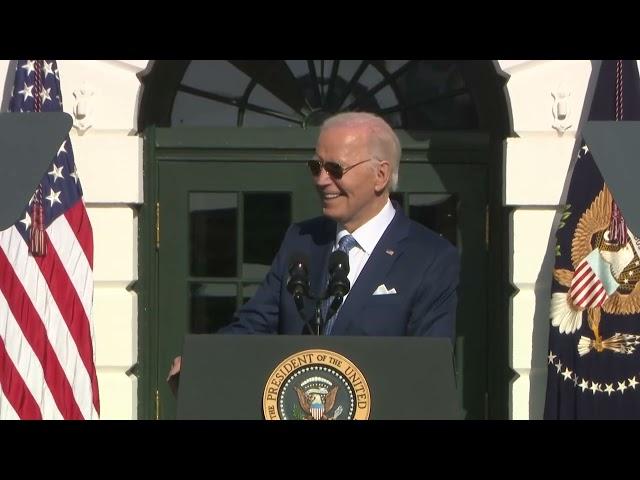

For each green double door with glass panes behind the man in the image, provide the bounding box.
[145,129,488,418]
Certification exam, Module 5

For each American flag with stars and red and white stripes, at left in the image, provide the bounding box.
[0,60,100,419]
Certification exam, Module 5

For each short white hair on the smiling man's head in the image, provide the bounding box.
[320,112,402,191]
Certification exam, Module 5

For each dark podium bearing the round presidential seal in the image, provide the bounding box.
[177,334,462,420]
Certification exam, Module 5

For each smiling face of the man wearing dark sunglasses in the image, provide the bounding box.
[313,126,389,232]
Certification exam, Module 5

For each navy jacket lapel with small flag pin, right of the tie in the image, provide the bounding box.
[332,205,410,335]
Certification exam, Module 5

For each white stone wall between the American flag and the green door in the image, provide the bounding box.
[58,60,147,419]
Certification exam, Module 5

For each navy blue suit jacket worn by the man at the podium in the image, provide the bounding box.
[220,205,460,342]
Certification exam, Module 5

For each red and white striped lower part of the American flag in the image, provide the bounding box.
[0,201,100,419]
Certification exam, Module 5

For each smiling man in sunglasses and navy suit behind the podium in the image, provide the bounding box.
[169,112,460,384]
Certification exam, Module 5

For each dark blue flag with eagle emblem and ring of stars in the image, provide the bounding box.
[544,60,640,419]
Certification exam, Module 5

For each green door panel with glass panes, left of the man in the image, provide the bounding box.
[157,161,320,418]
